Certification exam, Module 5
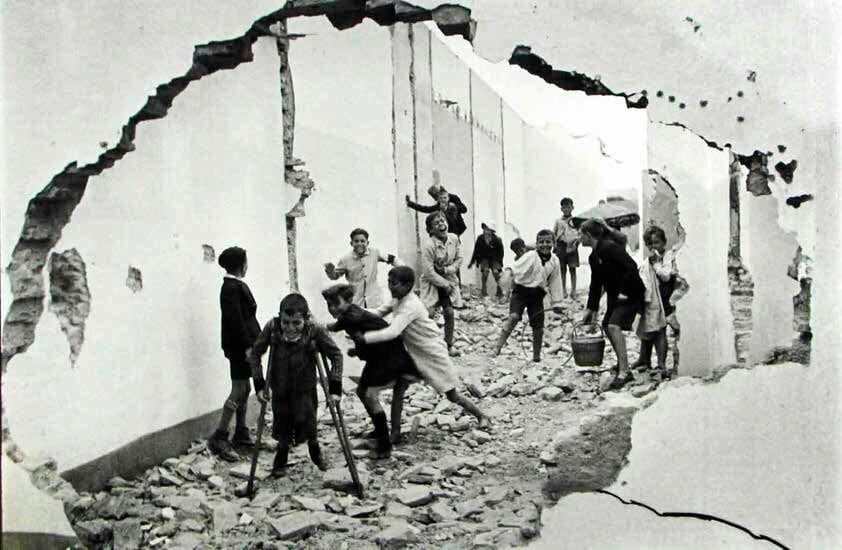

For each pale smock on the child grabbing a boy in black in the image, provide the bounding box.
[363,292,458,394]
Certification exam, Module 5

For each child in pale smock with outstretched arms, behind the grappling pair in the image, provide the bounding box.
[324,227,401,307]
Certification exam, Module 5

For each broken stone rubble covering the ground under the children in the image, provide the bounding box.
[67,295,658,550]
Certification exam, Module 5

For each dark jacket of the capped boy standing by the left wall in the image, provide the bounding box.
[219,277,260,359]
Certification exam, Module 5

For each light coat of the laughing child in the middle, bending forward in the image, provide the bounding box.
[419,233,462,313]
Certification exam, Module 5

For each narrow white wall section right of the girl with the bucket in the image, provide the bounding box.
[648,123,736,376]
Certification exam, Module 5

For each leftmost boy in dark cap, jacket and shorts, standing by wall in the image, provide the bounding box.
[208,246,263,462]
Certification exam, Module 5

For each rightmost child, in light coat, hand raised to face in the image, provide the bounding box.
[632,225,686,378]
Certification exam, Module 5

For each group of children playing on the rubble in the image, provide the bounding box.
[208,198,686,476]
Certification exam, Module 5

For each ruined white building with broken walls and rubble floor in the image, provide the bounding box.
[0,0,842,548]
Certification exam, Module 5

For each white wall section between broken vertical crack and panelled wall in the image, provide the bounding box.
[288,18,396,328]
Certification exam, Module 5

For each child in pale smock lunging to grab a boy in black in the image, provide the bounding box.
[354,266,491,429]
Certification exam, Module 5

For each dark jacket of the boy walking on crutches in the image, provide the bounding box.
[252,317,342,395]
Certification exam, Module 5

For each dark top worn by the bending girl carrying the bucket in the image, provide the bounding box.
[588,238,646,311]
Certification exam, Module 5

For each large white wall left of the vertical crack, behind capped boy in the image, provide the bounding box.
[3,39,287,469]
